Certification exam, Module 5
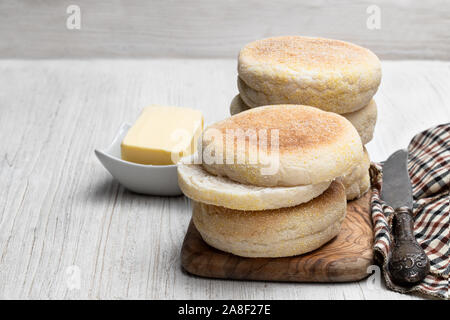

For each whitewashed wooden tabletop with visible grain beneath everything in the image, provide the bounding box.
[0,60,450,299]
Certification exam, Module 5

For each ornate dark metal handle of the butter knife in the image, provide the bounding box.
[388,207,430,286]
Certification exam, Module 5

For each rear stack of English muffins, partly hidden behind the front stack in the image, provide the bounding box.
[230,36,381,200]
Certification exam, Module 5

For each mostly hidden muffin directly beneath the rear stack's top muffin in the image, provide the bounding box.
[230,94,378,144]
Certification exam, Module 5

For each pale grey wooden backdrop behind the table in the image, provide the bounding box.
[0,0,450,60]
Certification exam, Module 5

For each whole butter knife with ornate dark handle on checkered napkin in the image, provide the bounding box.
[381,149,430,286]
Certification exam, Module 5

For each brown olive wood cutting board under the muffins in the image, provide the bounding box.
[181,192,373,282]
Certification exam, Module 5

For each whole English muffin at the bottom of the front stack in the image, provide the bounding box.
[192,181,347,257]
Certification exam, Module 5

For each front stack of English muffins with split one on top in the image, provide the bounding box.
[178,105,366,257]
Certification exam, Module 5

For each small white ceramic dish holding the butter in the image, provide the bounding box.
[95,123,182,196]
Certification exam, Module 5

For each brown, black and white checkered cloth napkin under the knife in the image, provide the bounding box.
[370,123,450,299]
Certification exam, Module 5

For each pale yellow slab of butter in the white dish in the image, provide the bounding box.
[121,105,203,165]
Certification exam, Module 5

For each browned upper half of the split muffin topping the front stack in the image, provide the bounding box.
[201,105,364,187]
